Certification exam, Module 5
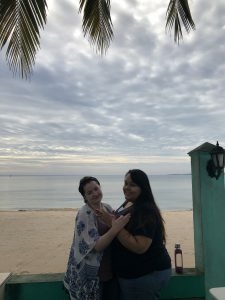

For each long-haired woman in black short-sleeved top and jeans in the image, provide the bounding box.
[112,169,171,300]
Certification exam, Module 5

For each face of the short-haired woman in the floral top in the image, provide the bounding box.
[84,181,102,208]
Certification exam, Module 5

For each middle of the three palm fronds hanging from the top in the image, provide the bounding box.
[79,0,113,54]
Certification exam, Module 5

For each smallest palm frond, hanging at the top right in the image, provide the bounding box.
[166,0,195,44]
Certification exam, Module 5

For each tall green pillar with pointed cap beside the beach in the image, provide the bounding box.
[188,143,225,300]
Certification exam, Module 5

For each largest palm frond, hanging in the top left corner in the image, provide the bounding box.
[0,0,47,78]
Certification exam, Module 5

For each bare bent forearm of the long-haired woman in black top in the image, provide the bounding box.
[117,228,152,254]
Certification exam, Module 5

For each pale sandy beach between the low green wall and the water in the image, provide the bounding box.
[0,209,195,274]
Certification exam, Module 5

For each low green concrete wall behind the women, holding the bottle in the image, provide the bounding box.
[5,269,205,300]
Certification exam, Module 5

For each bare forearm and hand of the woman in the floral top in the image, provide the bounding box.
[94,214,130,252]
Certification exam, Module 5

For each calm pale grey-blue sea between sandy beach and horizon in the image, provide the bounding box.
[0,175,192,211]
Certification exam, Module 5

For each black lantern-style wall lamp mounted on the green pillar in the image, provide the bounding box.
[207,142,225,180]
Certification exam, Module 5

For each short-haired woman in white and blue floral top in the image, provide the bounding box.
[64,176,130,300]
